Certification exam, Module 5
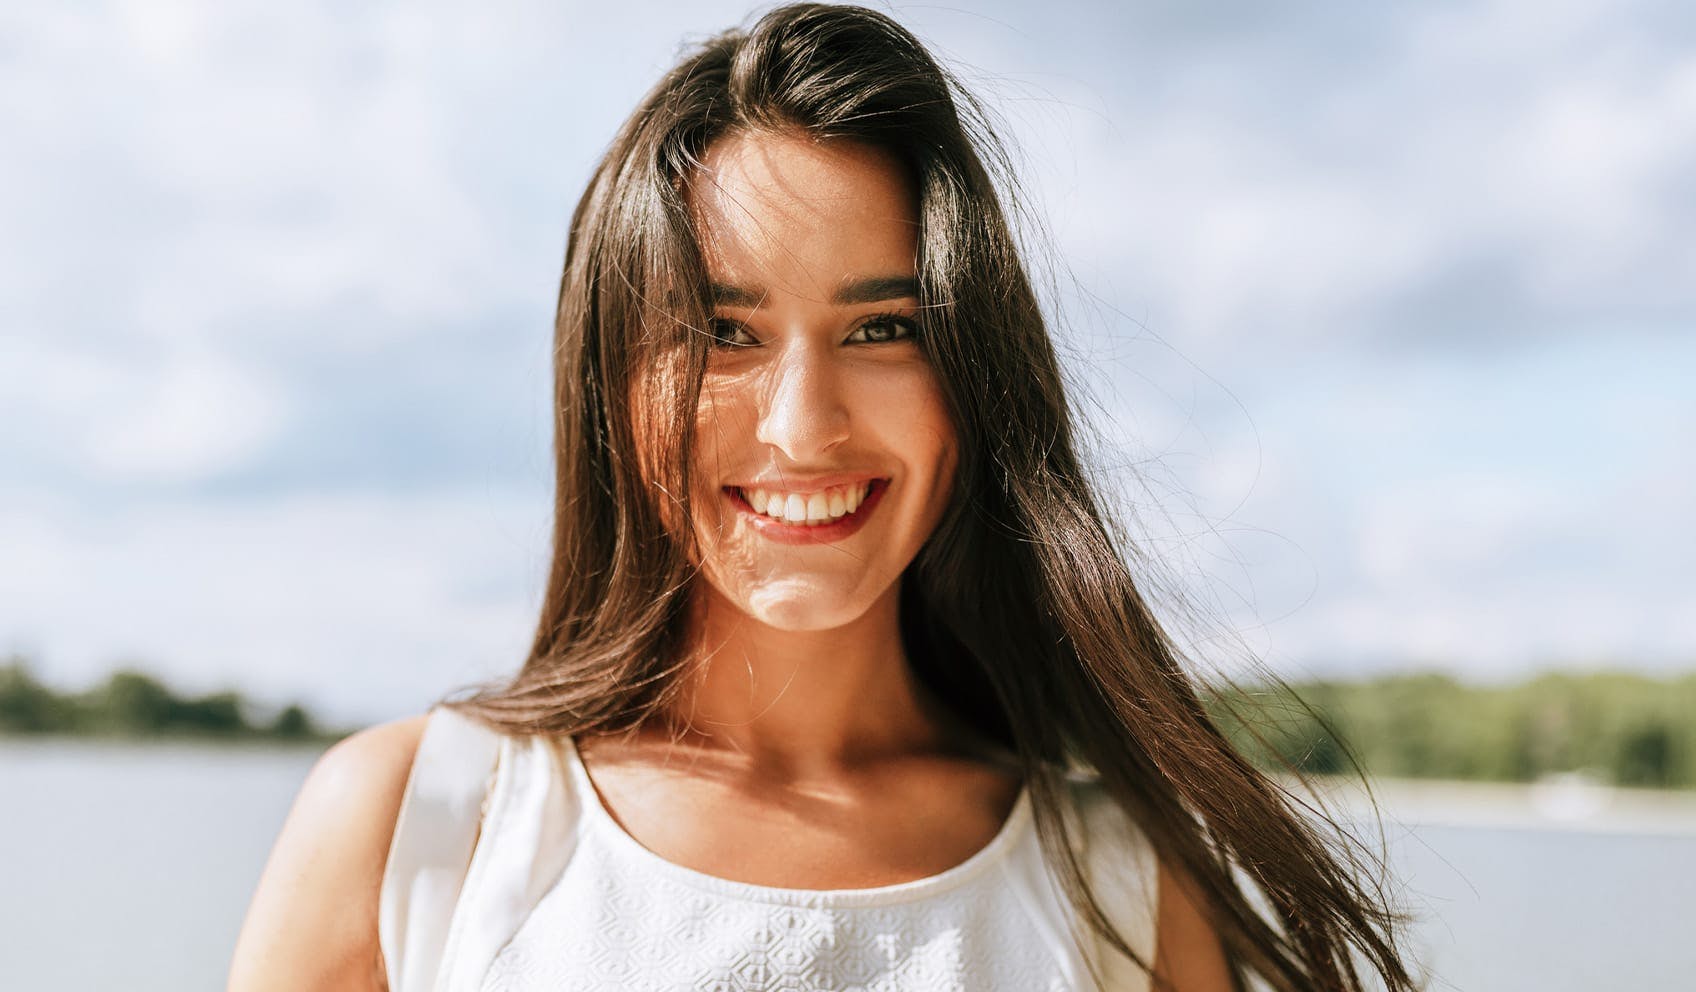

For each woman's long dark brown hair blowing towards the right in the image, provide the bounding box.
[453,3,1413,992]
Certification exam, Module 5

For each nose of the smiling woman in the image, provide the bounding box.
[755,341,848,465]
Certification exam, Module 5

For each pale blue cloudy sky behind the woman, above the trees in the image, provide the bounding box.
[0,0,1696,721]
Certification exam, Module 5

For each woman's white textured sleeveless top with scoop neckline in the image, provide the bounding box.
[378,709,1157,992]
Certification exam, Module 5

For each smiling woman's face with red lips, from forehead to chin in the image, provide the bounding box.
[689,132,957,631]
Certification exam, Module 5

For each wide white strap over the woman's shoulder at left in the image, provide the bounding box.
[386,707,500,992]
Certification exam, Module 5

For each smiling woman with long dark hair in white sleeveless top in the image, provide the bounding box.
[231,5,1411,992]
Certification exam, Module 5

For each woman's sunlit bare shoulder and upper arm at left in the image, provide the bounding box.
[229,716,426,992]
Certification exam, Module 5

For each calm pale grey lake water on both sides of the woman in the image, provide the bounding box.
[0,739,1696,992]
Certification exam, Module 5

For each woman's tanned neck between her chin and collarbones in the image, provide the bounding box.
[672,583,941,773]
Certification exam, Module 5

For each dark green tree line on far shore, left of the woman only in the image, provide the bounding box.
[0,658,343,743]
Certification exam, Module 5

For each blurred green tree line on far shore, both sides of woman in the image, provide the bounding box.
[0,658,1696,789]
